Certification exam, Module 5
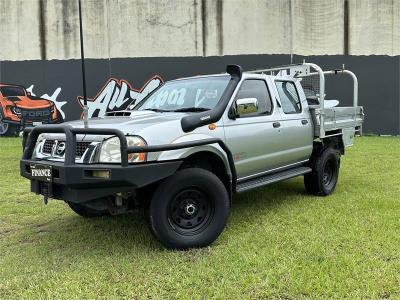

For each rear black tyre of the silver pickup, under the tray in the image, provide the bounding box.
[304,148,340,196]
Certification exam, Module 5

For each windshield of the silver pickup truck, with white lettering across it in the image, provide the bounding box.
[134,76,230,112]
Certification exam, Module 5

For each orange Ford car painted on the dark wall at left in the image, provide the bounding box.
[0,84,63,136]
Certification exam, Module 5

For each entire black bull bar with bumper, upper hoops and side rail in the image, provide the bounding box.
[20,124,236,203]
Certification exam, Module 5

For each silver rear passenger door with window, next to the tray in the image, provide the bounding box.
[274,79,313,165]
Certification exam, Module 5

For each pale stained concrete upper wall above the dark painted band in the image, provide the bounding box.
[0,0,400,61]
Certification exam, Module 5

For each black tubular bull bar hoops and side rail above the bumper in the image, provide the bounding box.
[22,124,237,191]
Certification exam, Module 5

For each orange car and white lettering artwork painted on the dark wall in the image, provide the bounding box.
[0,75,164,136]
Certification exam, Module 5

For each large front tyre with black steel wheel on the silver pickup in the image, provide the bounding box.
[148,168,229,249]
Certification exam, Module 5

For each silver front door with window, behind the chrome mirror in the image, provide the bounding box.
[223,78,283,179]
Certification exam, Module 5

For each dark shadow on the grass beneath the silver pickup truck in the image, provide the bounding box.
[22,180,304,258]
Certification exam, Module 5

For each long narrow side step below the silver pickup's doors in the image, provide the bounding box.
[236,167,312,193]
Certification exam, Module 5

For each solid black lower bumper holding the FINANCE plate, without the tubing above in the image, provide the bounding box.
[20,159,182,203]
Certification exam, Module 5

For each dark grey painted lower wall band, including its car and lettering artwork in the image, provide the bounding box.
[0,54,400,135]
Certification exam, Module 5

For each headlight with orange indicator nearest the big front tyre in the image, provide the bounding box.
[99,136,146,163]
